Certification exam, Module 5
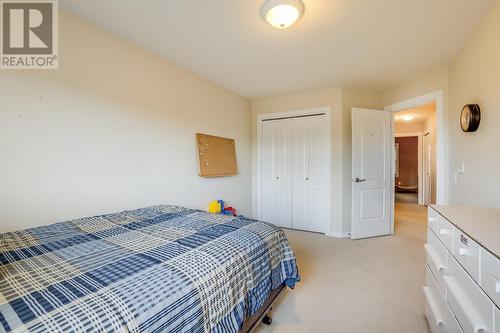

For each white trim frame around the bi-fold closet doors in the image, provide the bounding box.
[254,106,332,233]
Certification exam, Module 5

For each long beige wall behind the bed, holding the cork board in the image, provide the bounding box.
[0,11,251,228]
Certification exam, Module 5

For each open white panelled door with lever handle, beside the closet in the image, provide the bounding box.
[351,108,393,239]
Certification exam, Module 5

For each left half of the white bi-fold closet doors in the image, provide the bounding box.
[262,119,292,228]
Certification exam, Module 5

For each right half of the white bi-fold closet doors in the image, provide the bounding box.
[292,115,327,232]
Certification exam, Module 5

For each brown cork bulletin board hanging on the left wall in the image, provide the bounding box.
[196,133,238,177]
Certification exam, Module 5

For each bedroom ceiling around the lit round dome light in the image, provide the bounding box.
[60,0,494,98]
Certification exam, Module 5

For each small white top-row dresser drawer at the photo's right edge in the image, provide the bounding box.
[481,249,500,308]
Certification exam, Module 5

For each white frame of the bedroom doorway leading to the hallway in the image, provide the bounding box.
[384,90,448,233]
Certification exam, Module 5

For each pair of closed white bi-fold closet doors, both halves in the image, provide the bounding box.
[262,115,328,232]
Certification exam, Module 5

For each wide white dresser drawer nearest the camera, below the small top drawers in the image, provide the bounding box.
[443,253,494,333]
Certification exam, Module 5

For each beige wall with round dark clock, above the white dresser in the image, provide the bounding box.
[449,1,500,208]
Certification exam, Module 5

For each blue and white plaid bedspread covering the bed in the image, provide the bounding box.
[0,205,299,332]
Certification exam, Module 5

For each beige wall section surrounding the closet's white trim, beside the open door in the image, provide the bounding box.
[252,87,382,236]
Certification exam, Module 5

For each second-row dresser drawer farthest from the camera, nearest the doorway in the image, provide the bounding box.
[424,228,447,297]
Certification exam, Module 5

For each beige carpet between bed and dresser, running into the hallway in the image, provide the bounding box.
[256,203,429,333]
